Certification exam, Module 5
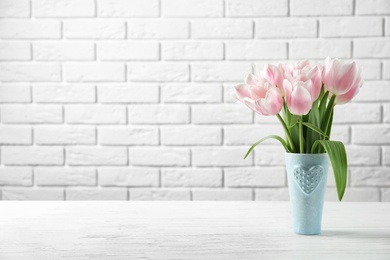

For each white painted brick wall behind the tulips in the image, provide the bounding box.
[0,0,390,201]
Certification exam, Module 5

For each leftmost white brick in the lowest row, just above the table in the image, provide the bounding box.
[2,188,64,200]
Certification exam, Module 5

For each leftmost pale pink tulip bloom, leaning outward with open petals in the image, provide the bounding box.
[234,74,283,116]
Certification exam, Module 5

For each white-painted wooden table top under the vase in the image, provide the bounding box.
[0,201,390,260]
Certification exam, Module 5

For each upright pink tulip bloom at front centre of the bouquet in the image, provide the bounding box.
[283,79,315,116]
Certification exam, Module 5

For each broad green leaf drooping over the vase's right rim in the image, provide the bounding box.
[312,140,348,201]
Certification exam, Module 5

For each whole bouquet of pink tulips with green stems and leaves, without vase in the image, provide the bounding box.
[233,57,362,200]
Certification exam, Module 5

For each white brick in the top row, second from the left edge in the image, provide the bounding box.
[32,0,95,17]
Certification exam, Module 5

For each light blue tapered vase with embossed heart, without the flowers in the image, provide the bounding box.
[285,153,329,235]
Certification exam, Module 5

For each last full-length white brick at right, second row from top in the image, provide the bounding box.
[320,17,383,37]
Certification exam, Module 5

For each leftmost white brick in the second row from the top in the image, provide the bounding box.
[0,19,61,40]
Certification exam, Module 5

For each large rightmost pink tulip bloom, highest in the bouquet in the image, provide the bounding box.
[322,57,361,100]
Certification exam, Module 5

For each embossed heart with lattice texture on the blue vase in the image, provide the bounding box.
[293,165,324,194]
